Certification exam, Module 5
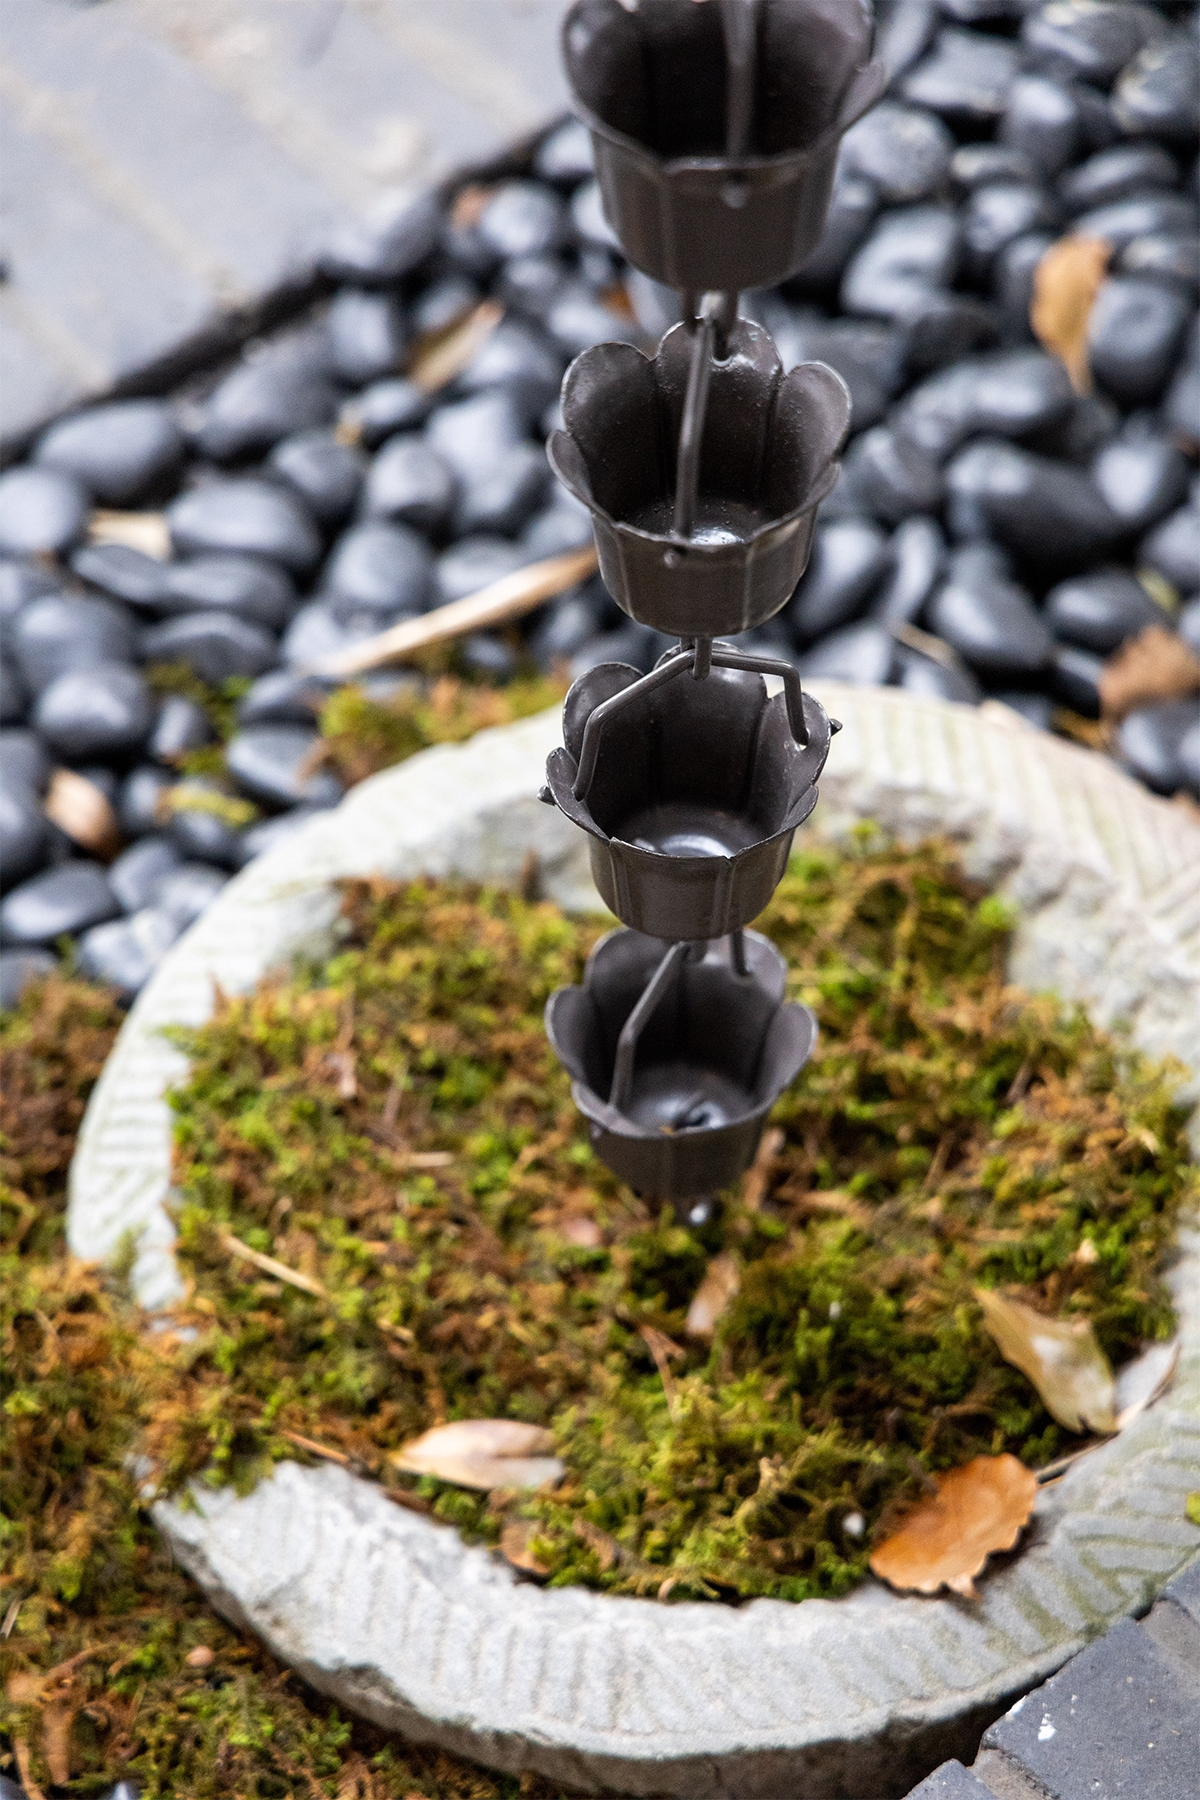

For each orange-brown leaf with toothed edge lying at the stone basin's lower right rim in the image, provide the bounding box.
[871,1454,1038,1600]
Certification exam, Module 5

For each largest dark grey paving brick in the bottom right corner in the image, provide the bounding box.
[981,1618,1200,1800]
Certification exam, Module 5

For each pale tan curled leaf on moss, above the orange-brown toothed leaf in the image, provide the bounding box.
[975,1287,1117,1433]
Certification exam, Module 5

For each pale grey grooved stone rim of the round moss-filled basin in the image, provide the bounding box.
[68,684,1200,1800]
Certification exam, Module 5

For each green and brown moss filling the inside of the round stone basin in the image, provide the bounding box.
[151,841,1189,1600]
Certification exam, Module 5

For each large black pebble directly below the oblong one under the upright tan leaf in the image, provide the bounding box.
[946,437,1121,571]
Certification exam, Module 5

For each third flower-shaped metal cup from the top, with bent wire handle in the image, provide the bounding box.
[545,662,831,941]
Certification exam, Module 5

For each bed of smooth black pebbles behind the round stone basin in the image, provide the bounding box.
[0,0,1200,1004]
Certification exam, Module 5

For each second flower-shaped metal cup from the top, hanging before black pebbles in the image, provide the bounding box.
[547,319,849,637]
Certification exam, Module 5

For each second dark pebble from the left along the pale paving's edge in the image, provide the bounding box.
[34,400,184,506]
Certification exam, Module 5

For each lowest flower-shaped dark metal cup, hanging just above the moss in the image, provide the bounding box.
[545,931,817,1201]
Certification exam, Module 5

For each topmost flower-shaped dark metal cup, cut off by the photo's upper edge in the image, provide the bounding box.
[563,0,887,293]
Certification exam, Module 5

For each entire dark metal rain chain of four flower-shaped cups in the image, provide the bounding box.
[542,0,883,1222]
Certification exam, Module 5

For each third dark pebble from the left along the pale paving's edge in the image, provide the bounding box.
[196,333,338,463]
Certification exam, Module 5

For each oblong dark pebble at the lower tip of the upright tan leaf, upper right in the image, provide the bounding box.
[894,349,1076,459]
